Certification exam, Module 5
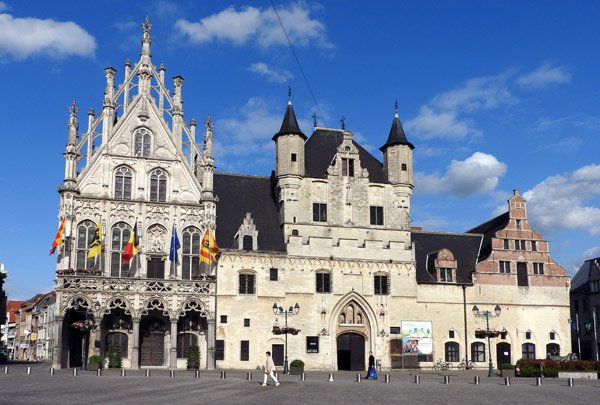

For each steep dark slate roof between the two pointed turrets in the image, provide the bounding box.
[304,128,388,183]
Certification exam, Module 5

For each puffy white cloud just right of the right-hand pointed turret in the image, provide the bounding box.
[415,152,506,198]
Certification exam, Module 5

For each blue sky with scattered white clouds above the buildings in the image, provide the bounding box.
[0,0,600,299]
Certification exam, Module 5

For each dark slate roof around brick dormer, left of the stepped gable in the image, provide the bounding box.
[411,230,483,284]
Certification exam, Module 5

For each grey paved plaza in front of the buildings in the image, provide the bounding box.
[0,363,600,405]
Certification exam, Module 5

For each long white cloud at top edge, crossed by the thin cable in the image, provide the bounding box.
[175,3,332,48]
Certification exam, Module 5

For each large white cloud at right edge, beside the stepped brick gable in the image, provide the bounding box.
[523,165,600,235]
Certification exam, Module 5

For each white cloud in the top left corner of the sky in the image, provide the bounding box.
[0,12,96,60]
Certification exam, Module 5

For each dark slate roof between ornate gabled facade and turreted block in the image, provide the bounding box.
[214,173,285,252]
